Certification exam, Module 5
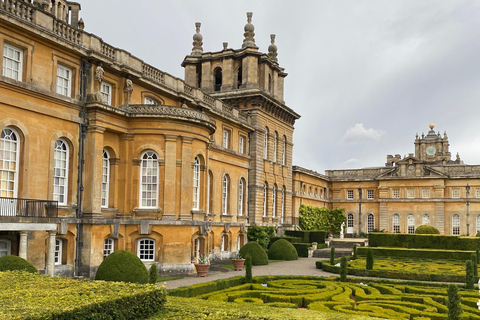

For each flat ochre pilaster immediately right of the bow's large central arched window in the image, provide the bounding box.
[162,134,178,220]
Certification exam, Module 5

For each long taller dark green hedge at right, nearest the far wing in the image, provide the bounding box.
[368,232,480,251]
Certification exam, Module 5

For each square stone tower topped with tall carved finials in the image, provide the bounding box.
[182,12,300,225]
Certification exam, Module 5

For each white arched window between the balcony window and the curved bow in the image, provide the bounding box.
[53,139,69,205]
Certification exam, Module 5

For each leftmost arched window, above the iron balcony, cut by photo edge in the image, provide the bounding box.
[0,128,20,198]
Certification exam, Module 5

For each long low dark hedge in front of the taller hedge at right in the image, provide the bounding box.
[357,247,475,261]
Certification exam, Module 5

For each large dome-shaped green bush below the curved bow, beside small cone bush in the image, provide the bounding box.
[95,250,149,283]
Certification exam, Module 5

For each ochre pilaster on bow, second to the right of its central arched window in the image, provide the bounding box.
[180,137,193,220]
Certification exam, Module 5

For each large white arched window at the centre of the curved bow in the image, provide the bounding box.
[140,151,158,208]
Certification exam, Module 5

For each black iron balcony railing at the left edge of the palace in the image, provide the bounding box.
[0,197,58,218]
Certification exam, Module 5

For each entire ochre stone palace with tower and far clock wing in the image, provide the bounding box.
[0,0,480,277]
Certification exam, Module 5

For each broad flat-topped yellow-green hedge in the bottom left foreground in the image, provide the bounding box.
[0,271,166,320]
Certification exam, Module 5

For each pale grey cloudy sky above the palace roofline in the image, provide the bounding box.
[79,0,480,173]
